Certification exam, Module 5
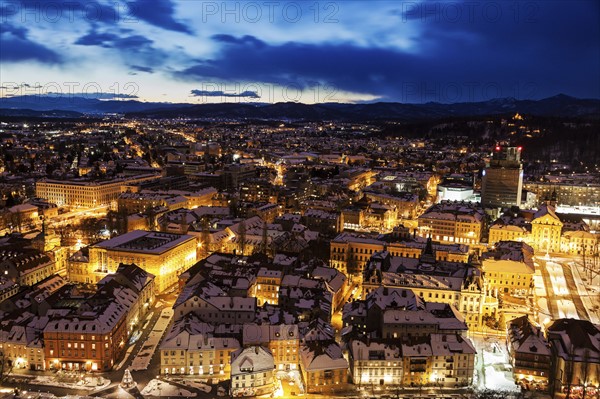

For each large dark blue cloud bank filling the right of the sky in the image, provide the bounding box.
[175,2,600,102]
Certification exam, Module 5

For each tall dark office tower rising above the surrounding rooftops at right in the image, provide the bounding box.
[481,146,523,208]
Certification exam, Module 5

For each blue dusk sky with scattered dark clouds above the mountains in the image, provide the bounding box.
[0,0,600,103]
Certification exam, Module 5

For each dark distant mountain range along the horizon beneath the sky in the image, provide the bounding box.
[0,94,600,121]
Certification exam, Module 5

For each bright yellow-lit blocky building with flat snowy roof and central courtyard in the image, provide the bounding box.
[82,230,197,292]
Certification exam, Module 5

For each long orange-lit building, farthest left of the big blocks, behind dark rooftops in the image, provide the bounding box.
[35,174,159,208]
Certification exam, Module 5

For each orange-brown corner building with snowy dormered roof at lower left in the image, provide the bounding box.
[43,265,154,371]
